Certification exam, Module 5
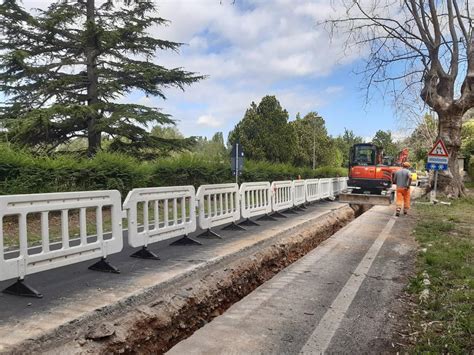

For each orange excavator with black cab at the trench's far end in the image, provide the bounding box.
[339,143,408,205]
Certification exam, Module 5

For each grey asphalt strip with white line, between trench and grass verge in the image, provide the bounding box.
[169,206,416,355]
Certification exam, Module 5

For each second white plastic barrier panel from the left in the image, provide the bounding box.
[123,186,196,248]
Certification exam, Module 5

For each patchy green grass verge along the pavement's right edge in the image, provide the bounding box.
[408,196,474,353]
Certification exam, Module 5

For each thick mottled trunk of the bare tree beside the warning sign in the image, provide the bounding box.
[438,112,465,197]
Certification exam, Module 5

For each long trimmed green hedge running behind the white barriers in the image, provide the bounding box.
[0,146,347,196]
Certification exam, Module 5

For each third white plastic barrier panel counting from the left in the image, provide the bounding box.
[196,184,240,229]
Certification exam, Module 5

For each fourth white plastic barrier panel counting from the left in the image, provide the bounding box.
[240,182,272,218]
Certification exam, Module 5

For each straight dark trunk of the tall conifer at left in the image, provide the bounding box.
[85,0,102,156]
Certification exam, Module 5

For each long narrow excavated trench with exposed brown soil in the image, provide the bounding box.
[11,206,365,354]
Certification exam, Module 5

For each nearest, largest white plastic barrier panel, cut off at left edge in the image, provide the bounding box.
[0,190,123,281]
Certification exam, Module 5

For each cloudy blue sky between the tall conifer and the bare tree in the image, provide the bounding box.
[17,0,400,142]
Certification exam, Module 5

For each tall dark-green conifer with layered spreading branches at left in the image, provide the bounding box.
[0,0,203,156]
